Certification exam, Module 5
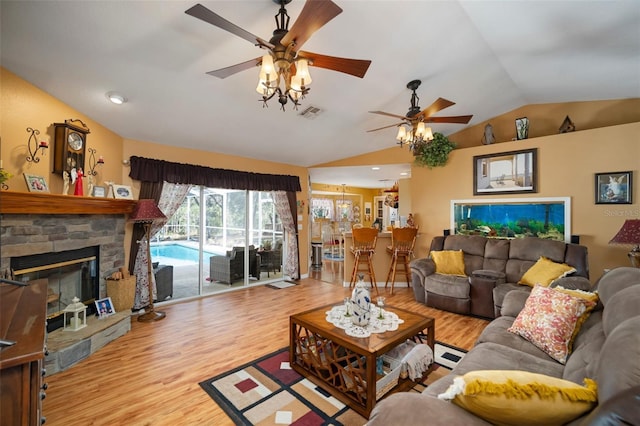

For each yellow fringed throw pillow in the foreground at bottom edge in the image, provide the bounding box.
[438,370,597,426]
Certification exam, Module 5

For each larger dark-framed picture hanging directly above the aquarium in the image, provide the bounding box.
[473,148,538,195]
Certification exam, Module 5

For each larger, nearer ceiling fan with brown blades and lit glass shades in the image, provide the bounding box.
[185,0,371,110]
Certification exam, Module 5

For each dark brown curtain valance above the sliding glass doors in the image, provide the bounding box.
[129,156,302,192]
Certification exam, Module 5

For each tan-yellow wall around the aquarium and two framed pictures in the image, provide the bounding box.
[411,123,640,281]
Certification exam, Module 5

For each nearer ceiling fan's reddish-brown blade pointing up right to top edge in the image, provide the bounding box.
[280,0,342,50]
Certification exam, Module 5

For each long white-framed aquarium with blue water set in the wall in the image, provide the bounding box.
[451,197,571,242]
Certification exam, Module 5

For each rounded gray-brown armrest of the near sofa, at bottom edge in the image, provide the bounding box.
[366,392,490,426]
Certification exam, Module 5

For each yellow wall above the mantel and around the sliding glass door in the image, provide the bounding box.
[0,68,310,275]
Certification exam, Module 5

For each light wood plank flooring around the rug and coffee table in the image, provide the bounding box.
[43,264,488,426]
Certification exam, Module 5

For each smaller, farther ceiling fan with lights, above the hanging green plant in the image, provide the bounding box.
[367,80,473,146]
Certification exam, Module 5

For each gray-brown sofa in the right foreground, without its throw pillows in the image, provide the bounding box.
[367,267,640,426]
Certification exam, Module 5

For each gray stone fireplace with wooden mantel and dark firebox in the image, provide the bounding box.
[0,191,135,331]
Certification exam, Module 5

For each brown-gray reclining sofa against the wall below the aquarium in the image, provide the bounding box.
[410,235,589,318]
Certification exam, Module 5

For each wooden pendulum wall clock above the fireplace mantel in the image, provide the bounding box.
[53,119,90,174]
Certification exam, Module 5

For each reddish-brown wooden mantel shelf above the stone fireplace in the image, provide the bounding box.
[0,191,137,214]
